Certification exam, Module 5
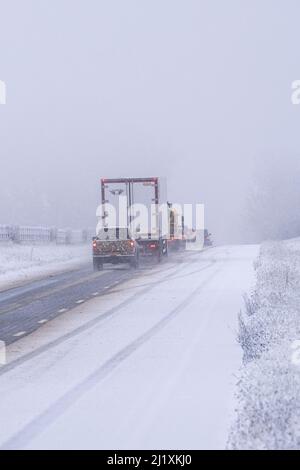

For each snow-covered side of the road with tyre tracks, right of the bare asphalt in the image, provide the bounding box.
[0,246,258,449]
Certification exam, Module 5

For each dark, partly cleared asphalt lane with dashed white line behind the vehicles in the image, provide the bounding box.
[0,263,151,345]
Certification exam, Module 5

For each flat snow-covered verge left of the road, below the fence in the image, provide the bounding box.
[0,242,91,291]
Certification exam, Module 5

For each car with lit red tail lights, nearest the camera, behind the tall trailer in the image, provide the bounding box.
[93,227,140,271]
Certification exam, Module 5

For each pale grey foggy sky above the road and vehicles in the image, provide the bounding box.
[0,0,300,242]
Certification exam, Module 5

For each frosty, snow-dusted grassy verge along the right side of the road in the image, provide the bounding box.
[228,239,300,449]
